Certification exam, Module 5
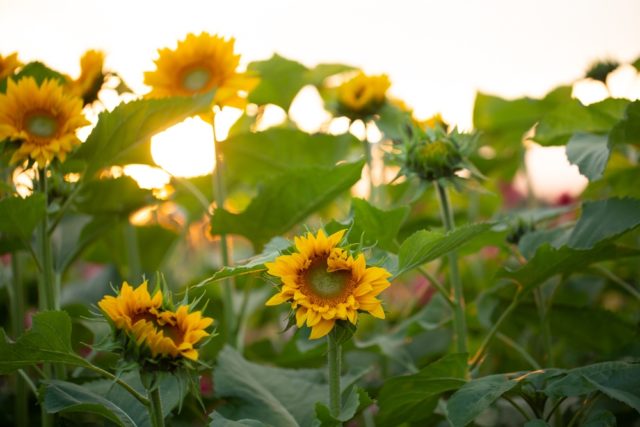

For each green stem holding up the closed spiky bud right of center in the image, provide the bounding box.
[435,181,467,353]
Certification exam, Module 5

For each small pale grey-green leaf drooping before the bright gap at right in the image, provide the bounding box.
[567,133,610,181]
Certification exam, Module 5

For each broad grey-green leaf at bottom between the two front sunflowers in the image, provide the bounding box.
[213,346,362,427]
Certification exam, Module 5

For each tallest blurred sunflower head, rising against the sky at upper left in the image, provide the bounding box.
[144,32,258,108]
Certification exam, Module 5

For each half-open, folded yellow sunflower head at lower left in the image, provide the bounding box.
[98,281,213,360]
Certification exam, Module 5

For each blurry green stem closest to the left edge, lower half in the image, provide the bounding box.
[9,252,29,426]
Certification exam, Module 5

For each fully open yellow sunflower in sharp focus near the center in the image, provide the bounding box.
[265,230,391,339]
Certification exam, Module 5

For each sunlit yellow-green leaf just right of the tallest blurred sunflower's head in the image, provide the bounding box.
[247,54,307,111]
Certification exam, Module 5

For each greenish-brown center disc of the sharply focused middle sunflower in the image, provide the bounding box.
[300,255,353,305]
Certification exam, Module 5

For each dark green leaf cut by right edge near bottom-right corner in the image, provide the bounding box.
[545,362,640,412]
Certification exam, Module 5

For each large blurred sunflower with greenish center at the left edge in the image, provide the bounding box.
[0,77,89,168]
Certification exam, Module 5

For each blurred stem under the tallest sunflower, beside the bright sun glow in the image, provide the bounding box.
[211,112,238,348]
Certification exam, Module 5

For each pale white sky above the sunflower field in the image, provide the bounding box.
[0,0,640,127]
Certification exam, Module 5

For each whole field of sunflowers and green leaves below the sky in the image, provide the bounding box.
[0,32,640,427]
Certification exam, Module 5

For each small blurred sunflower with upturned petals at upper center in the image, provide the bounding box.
[338,72,391,119]
